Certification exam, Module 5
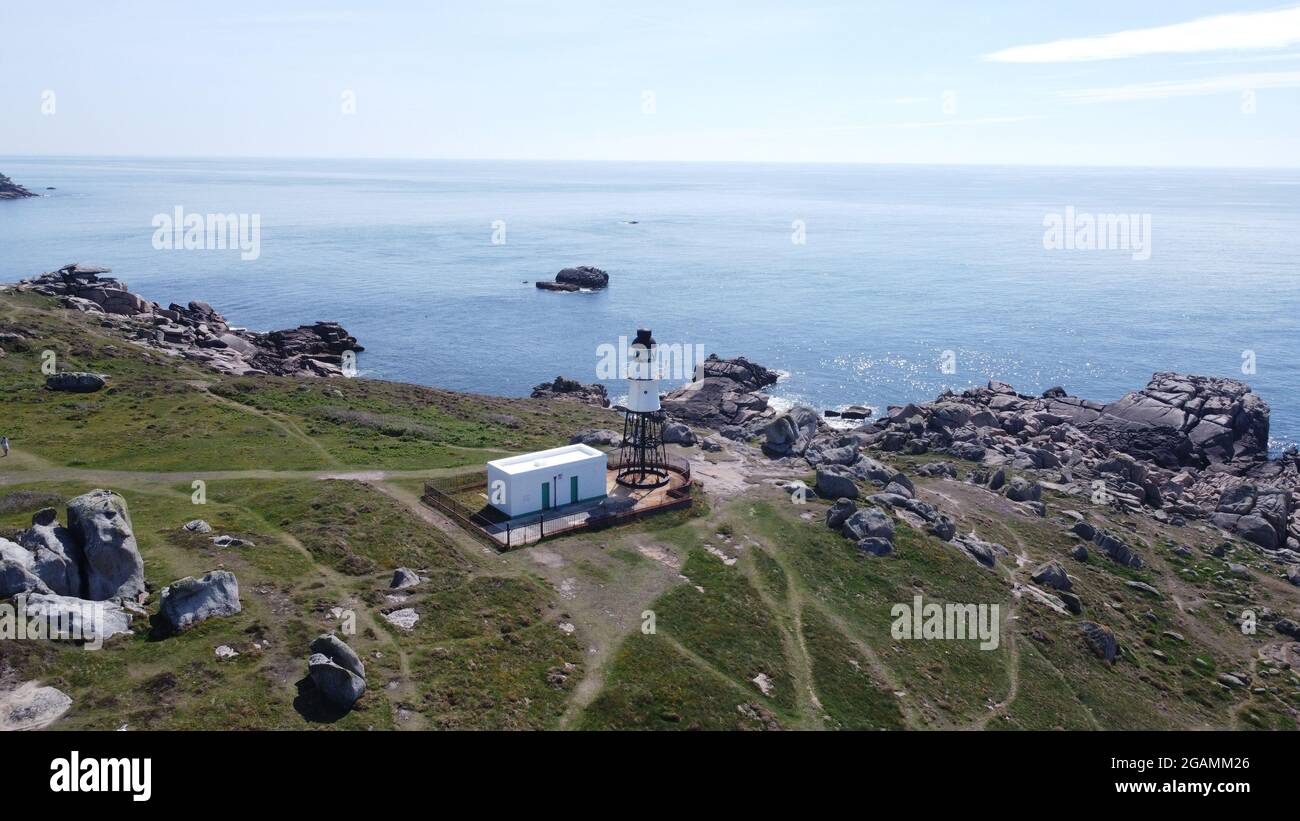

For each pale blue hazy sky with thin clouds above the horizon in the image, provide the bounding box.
[0,0,1300,168]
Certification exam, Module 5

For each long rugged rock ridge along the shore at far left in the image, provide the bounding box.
[14,262,364,379]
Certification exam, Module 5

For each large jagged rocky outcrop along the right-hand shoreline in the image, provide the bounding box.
[852,373,1300,548]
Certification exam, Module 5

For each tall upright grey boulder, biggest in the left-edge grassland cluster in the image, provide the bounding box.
[68,490,144,601]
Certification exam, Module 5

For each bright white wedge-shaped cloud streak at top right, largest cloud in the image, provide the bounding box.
[984,6,1300,62]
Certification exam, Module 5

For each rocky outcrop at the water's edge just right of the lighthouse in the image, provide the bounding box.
[662,353,779,428]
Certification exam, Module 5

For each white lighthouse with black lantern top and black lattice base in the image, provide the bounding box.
[615,327,668,487]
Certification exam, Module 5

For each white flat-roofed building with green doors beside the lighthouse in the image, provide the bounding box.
[488,444,606,517]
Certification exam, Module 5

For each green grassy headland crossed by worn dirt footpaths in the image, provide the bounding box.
[0,289,1300,730]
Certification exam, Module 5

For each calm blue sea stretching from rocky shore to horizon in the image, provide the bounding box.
[0,157,1300,444]
